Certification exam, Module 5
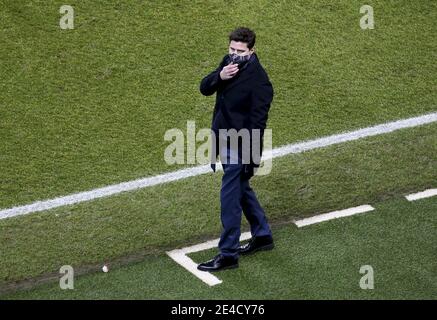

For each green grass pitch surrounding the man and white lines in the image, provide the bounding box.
[0,0,437,299]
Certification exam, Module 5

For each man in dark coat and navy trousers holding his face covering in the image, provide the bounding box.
[198,28,274,271]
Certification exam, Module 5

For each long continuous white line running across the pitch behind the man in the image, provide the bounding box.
[0,112,437,219]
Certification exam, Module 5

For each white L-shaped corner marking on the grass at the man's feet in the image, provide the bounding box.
[167,232,251,286]
